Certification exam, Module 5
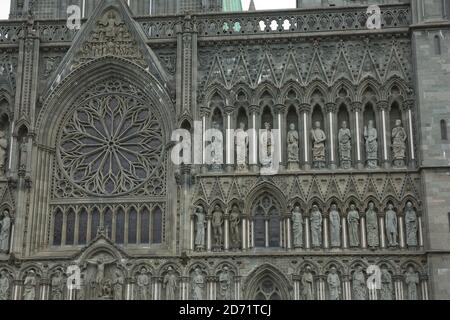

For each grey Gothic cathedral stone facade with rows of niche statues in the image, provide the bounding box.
[0,0,450,300]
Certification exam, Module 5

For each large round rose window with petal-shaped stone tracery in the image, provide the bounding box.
[58,93,163,196]
